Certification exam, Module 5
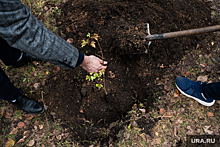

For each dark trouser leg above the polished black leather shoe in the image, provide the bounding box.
[0,68,21,101]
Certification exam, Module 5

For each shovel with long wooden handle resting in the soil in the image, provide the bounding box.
[145,23,220,41]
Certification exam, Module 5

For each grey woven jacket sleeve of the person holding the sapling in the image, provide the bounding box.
[0,0,82,68]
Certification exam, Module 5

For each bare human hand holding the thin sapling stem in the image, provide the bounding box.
[80,55,107,73]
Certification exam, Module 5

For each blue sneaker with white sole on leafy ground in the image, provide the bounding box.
[176,77,215,106]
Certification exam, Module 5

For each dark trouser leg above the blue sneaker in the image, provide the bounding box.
[203,82,220,100]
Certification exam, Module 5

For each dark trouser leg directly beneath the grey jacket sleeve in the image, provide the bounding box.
[0,38,21,66]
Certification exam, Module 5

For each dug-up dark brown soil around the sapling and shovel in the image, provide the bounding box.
[44,0,217,145]
